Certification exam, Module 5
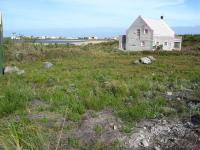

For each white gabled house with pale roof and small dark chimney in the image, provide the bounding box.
[119,16,182,51]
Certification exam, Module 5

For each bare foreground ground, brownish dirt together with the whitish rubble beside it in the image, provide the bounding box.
[47,110,200,150]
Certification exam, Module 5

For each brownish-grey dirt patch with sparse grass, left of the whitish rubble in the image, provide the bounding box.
[55,110,123,149]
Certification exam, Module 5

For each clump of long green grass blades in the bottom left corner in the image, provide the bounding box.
[0,120,46,150]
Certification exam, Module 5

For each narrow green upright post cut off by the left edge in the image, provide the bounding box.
[0,12,3,75]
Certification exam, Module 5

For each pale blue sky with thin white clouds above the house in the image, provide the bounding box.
[0,0,200,36]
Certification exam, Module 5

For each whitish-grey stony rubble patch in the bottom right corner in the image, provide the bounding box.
[124,120,200,150]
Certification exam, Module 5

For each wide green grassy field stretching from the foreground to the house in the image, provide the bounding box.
[0,41,200,150]
